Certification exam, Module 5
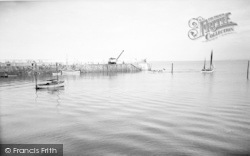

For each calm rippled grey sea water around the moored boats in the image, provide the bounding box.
[0,61,250,156]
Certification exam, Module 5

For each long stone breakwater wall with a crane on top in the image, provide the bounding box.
[0,64,141,76]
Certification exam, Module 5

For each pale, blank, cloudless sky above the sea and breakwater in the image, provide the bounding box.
[0,0,250,62]
